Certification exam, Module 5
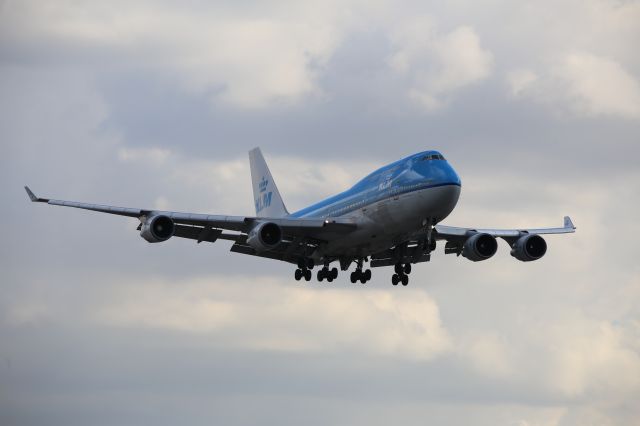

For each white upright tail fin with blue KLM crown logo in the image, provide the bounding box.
[249,148,289,217]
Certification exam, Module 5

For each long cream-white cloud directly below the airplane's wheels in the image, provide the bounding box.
[95,277,451,361]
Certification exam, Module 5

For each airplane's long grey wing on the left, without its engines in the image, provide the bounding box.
[25,186,357,243]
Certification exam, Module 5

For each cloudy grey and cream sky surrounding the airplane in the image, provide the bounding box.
[0,0,640,426]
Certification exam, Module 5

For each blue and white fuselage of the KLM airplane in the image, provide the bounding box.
[290,151,461,257]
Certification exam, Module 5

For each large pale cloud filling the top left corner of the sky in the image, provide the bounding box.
[0,1,350,108]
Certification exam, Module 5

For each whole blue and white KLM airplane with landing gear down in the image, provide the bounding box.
[25,148,576,286]
